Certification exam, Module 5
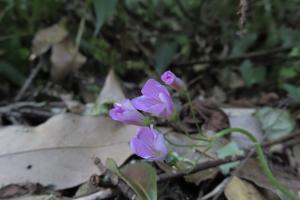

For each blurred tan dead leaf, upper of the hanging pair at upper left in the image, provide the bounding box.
[31,22,68,58]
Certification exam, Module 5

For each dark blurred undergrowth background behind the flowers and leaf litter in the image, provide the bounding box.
[0,0,300,119]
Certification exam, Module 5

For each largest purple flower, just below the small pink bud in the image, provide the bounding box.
[132,79,173,117]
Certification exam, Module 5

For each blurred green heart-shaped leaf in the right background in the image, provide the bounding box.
[240,60,266,87]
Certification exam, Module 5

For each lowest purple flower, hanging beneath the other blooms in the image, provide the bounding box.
[130,127,168,160]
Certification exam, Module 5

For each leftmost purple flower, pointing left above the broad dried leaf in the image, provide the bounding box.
[109,99,144,126]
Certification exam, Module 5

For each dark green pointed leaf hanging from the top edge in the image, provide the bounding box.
[93,0,118,35]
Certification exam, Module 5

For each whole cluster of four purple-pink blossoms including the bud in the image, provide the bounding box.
[109,71,184,160]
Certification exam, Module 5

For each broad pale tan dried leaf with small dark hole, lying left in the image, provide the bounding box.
[0,114,136,189]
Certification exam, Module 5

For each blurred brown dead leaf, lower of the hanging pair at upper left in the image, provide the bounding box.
[50,39,86,81]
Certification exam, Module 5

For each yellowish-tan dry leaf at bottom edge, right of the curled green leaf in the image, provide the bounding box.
[225,176,266,200]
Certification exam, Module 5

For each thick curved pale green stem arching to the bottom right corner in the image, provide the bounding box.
[213,128,299,200]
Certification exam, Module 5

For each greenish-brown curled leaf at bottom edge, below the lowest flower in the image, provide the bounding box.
[106,159,157,200]
